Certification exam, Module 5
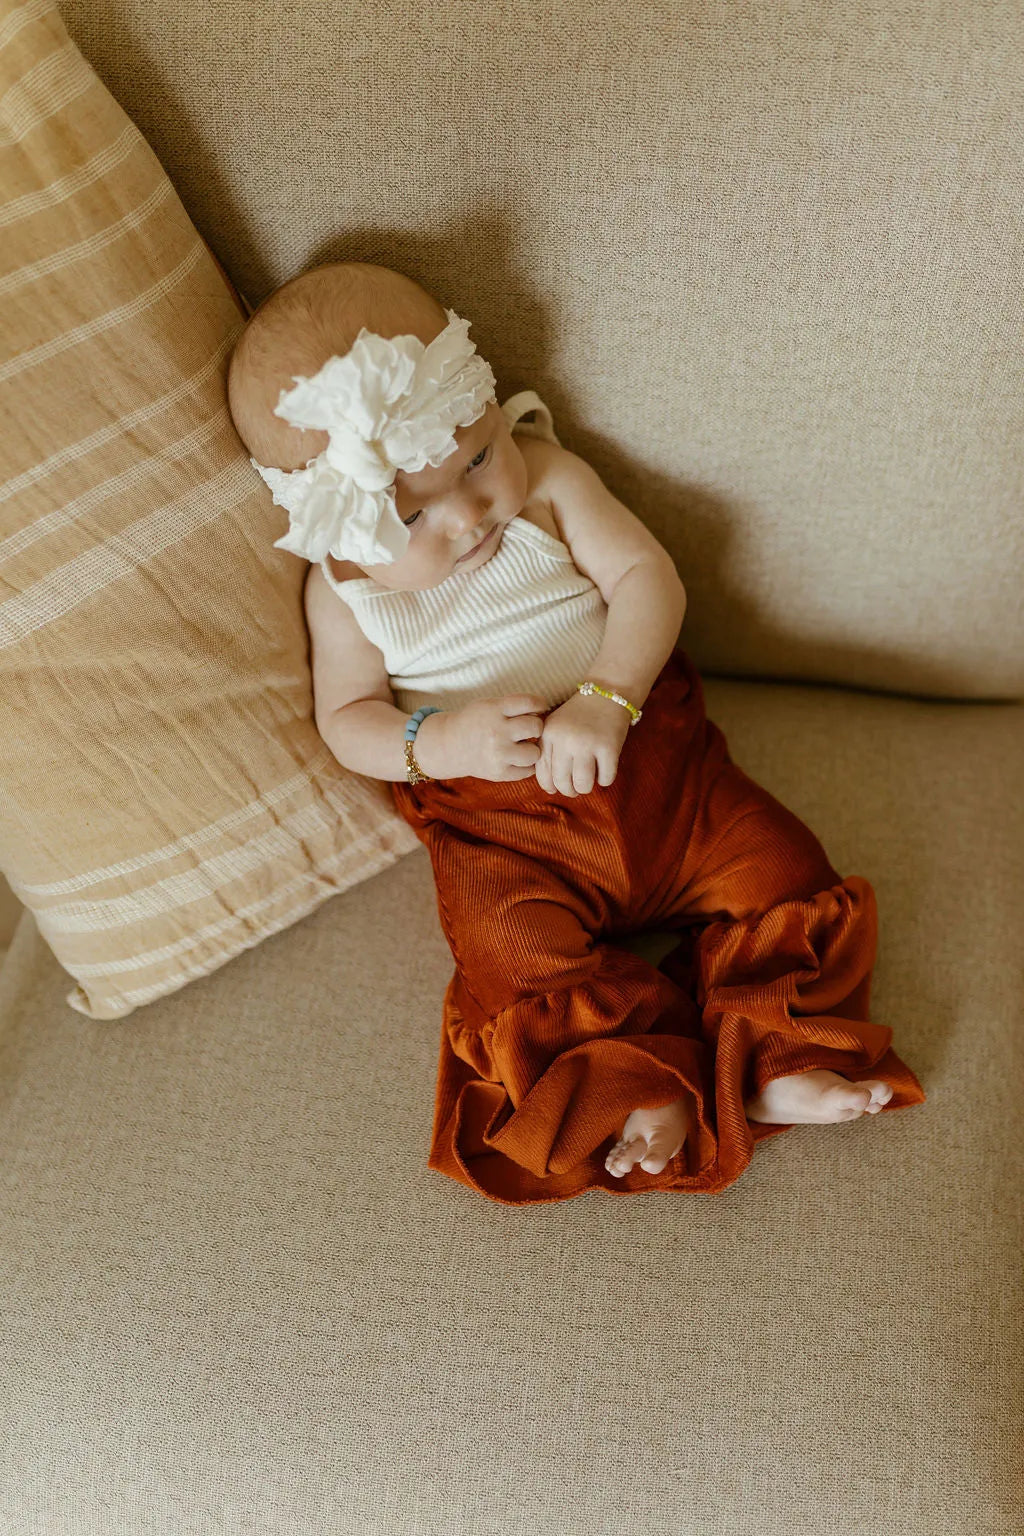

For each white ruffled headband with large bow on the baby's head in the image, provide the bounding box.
[252,309,496,565]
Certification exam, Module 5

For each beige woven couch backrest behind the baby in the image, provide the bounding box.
[63,0,1024,697]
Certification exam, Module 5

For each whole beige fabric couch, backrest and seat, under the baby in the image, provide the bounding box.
[0,0,1024,1536]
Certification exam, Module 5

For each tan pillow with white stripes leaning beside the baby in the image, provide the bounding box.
[0,0,418,1018]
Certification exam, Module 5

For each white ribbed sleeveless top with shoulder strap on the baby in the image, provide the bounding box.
[321,390,608,714]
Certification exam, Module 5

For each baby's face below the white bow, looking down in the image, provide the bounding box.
[359,401,527,591]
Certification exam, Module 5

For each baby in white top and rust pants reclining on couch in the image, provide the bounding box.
[229,263,924,1204]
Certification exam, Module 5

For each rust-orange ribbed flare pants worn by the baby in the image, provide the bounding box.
[391,650,924,1206]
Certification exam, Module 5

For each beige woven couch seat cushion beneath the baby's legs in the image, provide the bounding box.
[0,679,1024,1536]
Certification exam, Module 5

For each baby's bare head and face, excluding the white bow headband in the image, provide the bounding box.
[227,261,527,590]
